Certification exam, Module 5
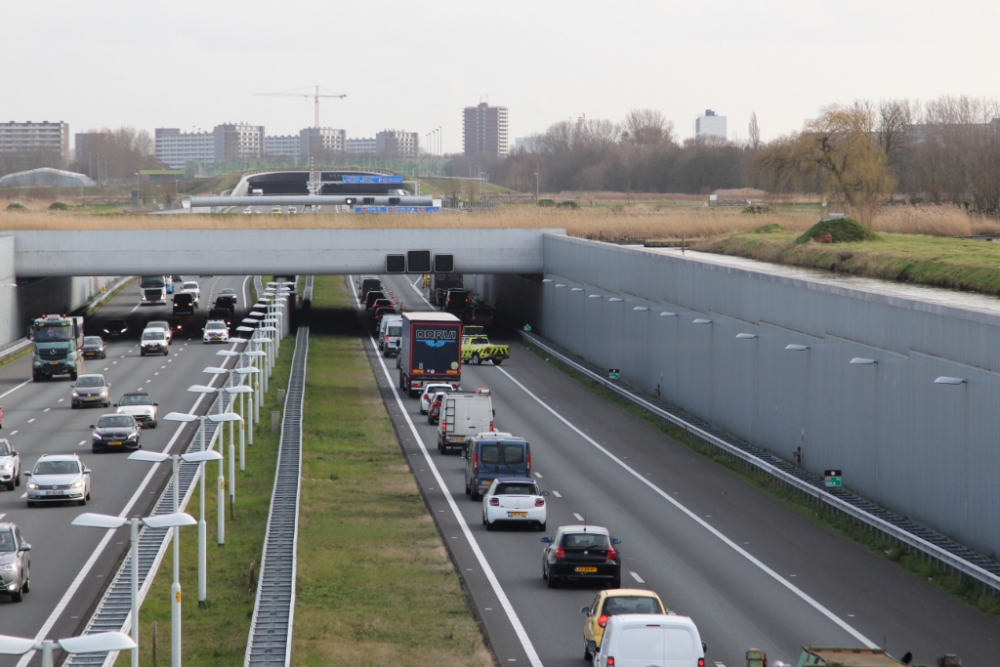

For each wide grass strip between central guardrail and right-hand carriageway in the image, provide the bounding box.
[292,276,493,667]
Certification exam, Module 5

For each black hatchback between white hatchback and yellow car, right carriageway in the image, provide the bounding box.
[542,525,622,588]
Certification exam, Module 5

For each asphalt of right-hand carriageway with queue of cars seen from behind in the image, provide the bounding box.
[362,276,1000,667]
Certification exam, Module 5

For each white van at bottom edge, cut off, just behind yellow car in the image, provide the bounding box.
[594,614,705,667]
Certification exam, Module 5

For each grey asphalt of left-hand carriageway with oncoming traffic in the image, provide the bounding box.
[0,276,249,667]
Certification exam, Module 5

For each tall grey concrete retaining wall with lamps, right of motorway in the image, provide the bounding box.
[471,236,1000,554]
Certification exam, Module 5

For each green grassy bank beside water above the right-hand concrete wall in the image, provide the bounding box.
[692,232,1000,295]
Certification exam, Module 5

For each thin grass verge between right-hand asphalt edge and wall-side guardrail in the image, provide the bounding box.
[525,344,1000,620]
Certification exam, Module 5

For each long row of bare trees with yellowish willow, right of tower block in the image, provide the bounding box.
[490,96,1000,221]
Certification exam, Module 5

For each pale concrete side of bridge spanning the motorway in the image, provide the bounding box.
[4,228,566,278]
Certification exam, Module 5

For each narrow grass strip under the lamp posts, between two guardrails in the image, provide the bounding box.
[115,338,295,667]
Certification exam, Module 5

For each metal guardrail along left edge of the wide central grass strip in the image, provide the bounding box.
[243,324,312,667]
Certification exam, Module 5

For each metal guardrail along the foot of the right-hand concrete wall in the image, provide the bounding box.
[515,329,1000,595]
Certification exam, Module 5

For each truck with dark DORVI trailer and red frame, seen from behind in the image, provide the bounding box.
[396,312,462,396]
